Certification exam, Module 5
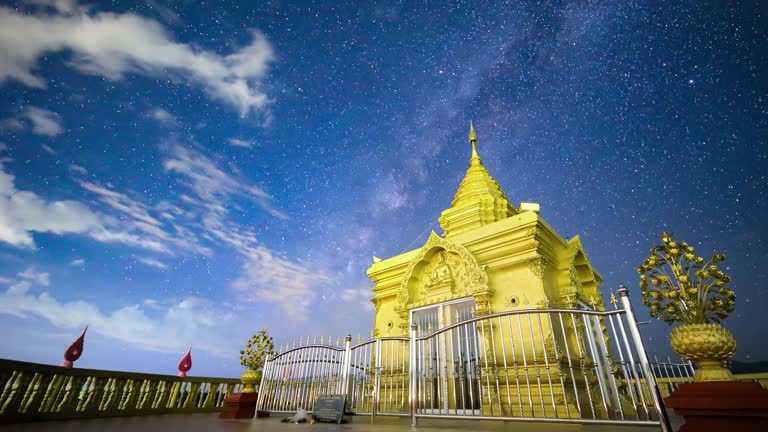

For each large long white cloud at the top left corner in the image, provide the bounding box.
[0,2,274,117]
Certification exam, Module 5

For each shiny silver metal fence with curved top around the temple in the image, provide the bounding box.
[258,289,673,431]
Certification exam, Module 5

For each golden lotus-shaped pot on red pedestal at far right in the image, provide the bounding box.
[669,324,736,382]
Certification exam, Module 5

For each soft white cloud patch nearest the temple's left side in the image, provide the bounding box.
[233,246,333,319]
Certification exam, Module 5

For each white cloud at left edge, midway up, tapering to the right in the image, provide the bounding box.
[0,163,101,247]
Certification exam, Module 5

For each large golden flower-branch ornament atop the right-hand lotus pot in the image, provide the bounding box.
[637,233,736,325]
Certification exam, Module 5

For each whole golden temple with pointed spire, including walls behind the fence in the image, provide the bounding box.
[368,122,612,417]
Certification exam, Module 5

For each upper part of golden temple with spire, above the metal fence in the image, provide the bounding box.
[368,122,604,336]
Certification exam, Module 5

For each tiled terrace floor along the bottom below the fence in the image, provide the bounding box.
[0,414,682,432]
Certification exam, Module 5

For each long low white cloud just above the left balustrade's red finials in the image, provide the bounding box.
[0,281,239,358]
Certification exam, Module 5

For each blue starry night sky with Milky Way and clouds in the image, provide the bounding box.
[0,0,768,377]
